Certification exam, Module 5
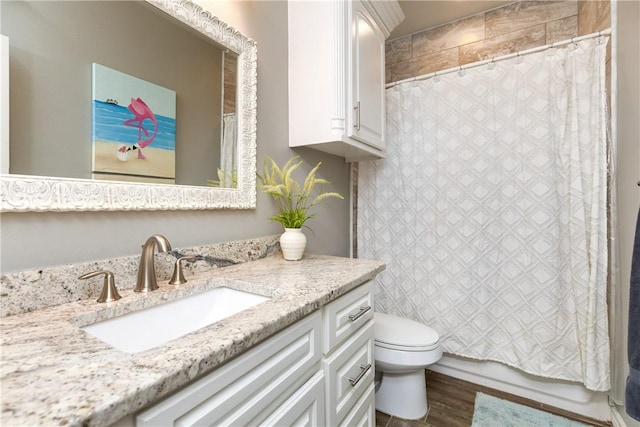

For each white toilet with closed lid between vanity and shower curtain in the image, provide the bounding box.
[373,313,442,419]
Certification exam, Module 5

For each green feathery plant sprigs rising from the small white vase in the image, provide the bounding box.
[257,156,344,228]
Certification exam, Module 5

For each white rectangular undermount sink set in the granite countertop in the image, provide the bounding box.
[82,287,269,353]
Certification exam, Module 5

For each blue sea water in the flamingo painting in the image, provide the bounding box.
[93,99,176,151]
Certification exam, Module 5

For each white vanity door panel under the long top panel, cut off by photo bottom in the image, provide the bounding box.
[262,371,326,427]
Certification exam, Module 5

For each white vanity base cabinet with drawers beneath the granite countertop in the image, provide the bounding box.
[134,283,375,427]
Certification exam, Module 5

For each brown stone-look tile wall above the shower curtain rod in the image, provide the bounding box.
[386,0,611,83]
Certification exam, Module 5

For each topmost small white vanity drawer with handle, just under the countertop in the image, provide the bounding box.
[322,282,373,354]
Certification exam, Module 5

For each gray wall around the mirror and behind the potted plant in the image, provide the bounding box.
[0,1,349,272]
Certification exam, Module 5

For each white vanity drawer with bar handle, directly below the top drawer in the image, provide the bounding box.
[323,321,375,426]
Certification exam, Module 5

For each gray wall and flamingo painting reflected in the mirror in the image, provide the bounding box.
[2,1,230,185]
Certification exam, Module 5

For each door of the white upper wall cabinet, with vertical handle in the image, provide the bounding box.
[350,1,385,149]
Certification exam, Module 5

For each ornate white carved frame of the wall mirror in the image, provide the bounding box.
[0,0,257,212]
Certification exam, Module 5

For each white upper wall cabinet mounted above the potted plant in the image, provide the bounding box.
[289,0,404,161]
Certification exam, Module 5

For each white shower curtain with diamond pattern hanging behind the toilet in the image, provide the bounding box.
[357,37,609,391]
